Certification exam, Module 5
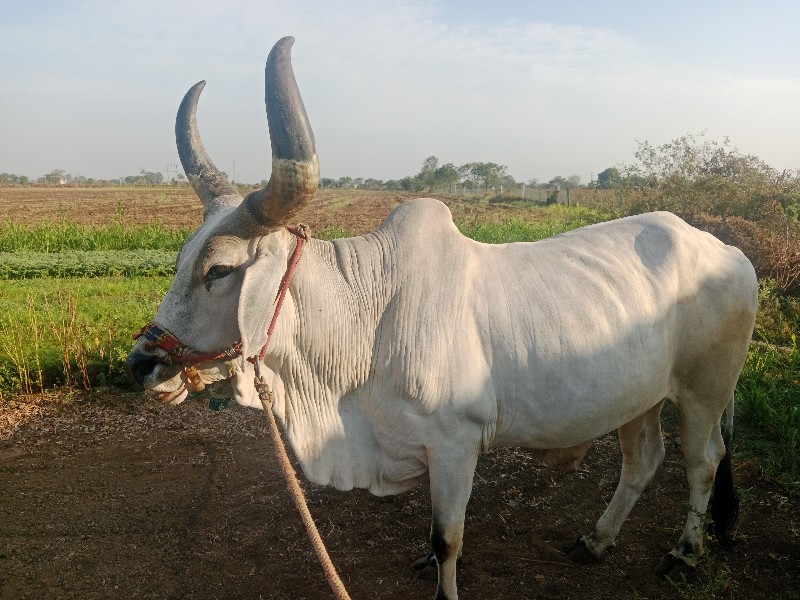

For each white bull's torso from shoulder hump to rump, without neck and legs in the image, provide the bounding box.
[376,200,755,448]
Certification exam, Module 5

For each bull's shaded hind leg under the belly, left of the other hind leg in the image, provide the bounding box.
[567,401,664,564]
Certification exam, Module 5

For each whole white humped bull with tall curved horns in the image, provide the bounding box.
[128,38,757,599]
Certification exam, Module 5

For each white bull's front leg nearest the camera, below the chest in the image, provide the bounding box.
[428,444,480,600]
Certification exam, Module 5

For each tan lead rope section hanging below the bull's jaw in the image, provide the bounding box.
[255,376,350,600]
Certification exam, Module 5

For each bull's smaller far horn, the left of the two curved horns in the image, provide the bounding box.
[175,81,238,214]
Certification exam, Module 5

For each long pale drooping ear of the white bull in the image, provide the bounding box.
[237,230,289,358]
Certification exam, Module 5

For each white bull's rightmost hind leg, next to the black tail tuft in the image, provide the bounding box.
[656,394,738,575]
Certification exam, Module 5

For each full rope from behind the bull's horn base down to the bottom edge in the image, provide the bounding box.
[247,225,350,600]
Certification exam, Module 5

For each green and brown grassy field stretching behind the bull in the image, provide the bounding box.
[0,188,800,490]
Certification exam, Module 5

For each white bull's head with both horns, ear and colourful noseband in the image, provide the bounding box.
[127,37,319,404]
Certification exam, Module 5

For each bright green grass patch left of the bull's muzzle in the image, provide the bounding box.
[0,276,172,394]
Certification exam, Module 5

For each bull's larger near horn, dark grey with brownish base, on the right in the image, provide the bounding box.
[244,37,319,228]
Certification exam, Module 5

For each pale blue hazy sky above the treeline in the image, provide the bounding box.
[0,0,800,182]
